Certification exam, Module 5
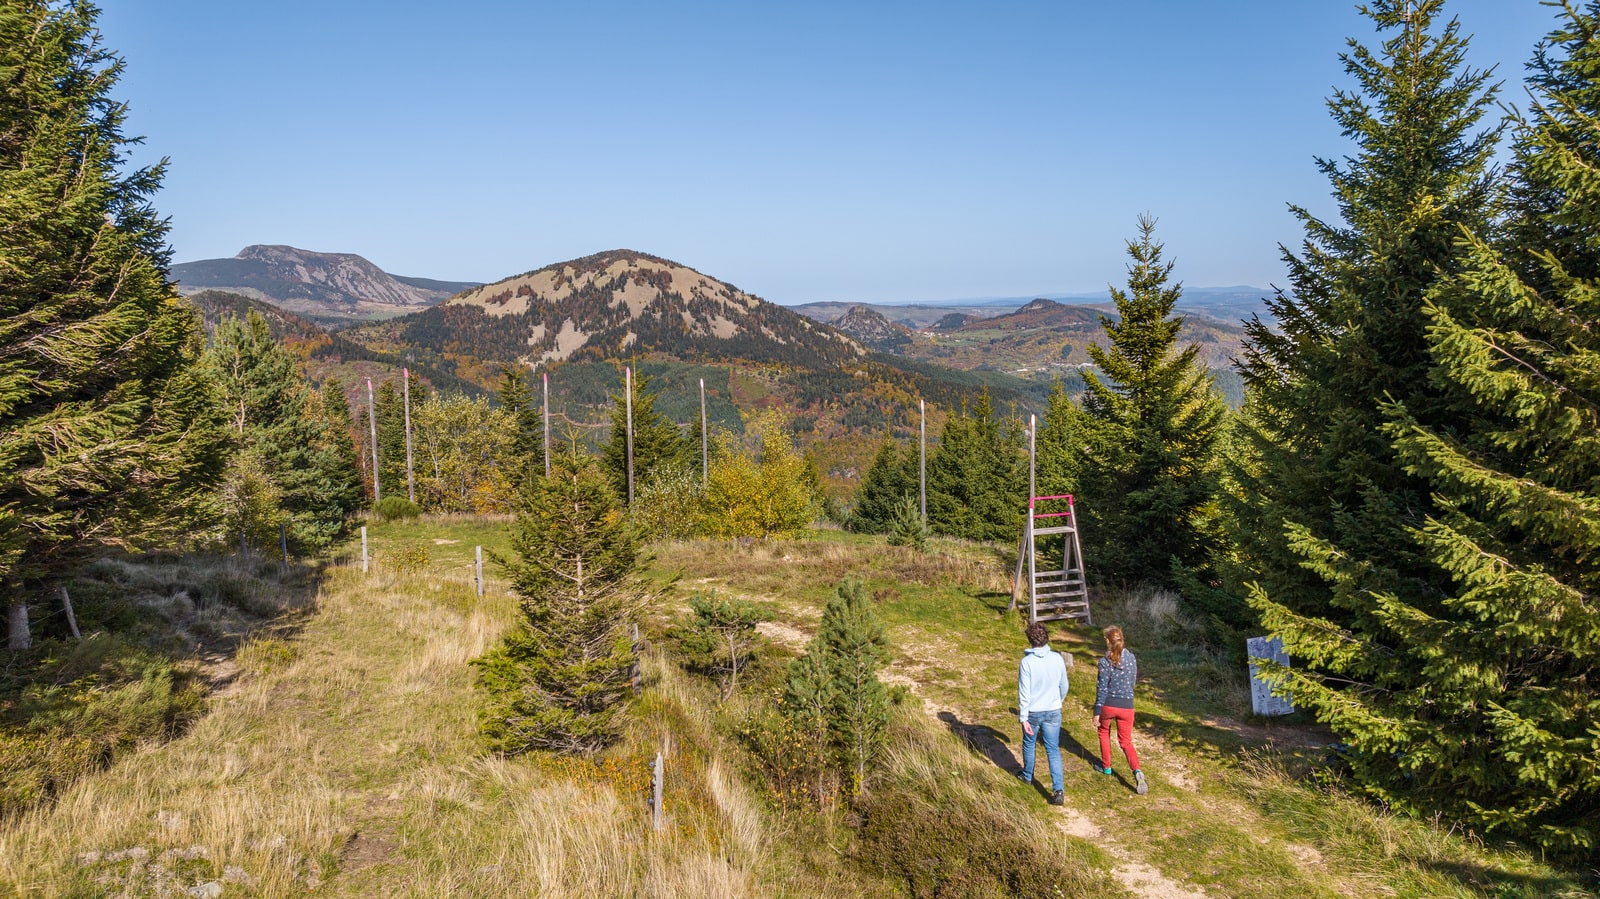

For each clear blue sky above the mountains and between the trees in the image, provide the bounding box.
[101,0,1554,302]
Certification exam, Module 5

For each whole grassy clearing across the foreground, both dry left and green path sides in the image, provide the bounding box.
[0,518,1586,897]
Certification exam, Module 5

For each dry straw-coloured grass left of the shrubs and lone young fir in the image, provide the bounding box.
[0,547,793,897]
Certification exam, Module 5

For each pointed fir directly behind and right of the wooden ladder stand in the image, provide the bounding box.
[1075,216,1226,582]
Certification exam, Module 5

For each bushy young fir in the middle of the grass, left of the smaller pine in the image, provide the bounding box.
[474,446,653,755]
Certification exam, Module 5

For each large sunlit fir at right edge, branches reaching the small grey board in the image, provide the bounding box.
[1261,3,1600,857]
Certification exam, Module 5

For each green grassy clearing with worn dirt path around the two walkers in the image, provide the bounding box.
[658,533,1595,897]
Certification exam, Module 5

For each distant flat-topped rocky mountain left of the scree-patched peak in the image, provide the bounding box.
[170,245,477,326]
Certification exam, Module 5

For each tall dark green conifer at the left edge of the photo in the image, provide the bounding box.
[0,2,227,648]
